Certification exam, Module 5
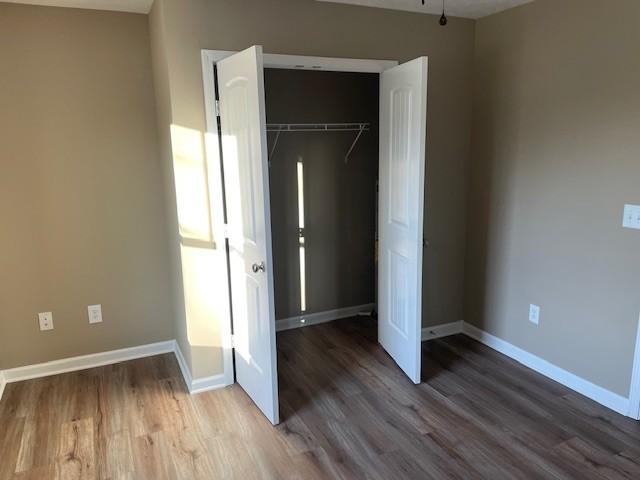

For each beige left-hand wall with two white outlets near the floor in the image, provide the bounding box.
[0,3,174,368]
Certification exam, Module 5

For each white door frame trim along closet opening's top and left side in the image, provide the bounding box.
[201,49,399,385]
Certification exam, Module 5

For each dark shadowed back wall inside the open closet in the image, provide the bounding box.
[265,69,379,319]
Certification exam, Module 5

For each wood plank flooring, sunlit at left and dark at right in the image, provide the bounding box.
[0,319,640,480]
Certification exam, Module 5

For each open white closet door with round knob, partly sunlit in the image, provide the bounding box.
[214,46,279,425]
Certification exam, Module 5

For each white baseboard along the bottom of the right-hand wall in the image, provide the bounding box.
[462,322,629,416]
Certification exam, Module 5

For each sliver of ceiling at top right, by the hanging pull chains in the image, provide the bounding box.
[317,0,533,18]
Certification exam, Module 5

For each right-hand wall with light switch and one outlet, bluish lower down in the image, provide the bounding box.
[465,0,640,396]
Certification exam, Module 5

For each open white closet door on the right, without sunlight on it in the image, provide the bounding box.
[378,57,427,383]
